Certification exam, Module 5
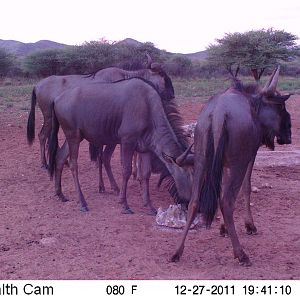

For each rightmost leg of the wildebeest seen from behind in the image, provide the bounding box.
[240,159,257,234]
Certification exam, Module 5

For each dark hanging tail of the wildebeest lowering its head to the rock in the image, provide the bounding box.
[48,103,59,179]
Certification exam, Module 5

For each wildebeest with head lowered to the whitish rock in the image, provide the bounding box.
[49,78,192,213]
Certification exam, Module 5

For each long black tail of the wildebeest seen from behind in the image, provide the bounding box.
[200,120,228,227]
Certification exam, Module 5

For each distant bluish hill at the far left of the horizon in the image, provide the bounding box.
[0,39,68,57]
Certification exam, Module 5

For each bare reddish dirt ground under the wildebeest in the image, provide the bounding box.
[0,96,300,279]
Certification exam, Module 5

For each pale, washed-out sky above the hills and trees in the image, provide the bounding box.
[0,0,300,53]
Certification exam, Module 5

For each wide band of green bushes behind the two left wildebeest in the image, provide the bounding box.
[23,41,169,77]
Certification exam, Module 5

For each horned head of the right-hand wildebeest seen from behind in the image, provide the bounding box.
[259,67,291,149]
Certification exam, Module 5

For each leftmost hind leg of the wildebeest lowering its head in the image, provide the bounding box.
[55,141,69,202]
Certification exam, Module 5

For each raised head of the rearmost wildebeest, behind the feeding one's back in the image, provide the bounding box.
[146,54,175,101]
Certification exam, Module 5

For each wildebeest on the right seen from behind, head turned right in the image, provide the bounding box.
[171,67,291,266]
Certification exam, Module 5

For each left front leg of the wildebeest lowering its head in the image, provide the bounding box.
[120,142,135,214]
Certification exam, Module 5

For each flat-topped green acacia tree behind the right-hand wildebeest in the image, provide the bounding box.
[207,28,300,81]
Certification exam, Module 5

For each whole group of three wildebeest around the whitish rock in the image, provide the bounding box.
[27,56,291,266]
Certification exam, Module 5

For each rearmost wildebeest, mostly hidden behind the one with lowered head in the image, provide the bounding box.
[27,55,174,176]
